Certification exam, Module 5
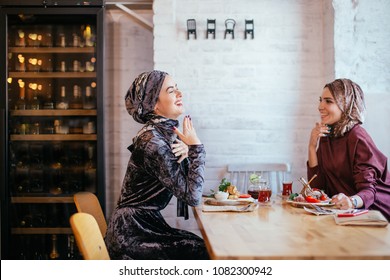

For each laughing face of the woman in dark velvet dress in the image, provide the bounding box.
[154,76,184,120]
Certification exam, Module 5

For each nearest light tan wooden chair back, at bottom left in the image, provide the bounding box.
[70,213,110,260]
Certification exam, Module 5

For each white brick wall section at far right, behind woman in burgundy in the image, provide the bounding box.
[333,0,390,157]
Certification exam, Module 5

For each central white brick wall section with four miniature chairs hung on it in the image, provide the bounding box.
[153,0,324,195]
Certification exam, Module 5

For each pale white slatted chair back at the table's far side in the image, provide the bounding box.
[227,163,291,194]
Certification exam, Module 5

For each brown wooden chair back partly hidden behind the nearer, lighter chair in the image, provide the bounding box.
[73,192,107,237]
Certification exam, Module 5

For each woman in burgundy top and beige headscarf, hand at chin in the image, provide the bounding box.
[307,79,390,220]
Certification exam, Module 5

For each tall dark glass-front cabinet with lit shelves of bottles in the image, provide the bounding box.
[0,0,105,259]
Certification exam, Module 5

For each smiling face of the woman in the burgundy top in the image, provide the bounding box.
[318,87,342,125]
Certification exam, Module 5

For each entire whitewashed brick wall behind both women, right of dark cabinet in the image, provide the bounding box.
[105,0,390,231]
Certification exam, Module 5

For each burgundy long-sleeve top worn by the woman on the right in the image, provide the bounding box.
[307,125,390,221]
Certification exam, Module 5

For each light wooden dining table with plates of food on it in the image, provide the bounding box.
[194,198,390,260]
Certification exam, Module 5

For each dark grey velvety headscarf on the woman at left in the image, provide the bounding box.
[125,70,168,123]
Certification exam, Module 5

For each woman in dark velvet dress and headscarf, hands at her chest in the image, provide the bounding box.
[105,70,209,260]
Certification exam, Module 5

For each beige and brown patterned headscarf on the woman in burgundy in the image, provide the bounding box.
[324,79,365,137]
